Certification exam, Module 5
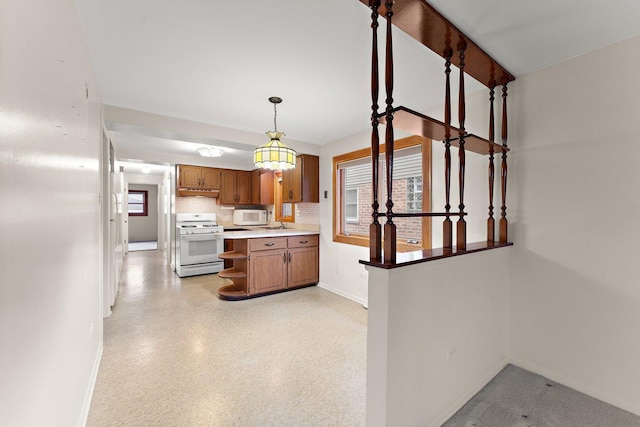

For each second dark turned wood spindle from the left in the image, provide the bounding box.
[384,0,396,264]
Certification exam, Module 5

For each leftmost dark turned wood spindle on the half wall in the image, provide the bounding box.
[369,0,382,262]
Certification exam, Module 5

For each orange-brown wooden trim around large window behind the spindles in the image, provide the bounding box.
[332,136,432,252]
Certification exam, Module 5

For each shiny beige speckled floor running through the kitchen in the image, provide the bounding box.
[87,251,367,426]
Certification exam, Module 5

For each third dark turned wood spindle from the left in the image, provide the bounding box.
[442,48,453,249]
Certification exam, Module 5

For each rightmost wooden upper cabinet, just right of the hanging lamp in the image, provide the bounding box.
[282,154,320,203]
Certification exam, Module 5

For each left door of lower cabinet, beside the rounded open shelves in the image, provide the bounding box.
[249,249,287,295]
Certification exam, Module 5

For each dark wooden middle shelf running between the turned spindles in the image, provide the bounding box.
[379,106,509,155]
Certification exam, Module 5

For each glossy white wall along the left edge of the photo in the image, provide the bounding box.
[0,0,102,426]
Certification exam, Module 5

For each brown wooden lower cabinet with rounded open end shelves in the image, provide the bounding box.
[218,235,320,300]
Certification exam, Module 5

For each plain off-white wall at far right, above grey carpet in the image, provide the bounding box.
[510,38,640,414]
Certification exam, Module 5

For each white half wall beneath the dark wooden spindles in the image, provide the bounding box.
[367,248,512,427]
